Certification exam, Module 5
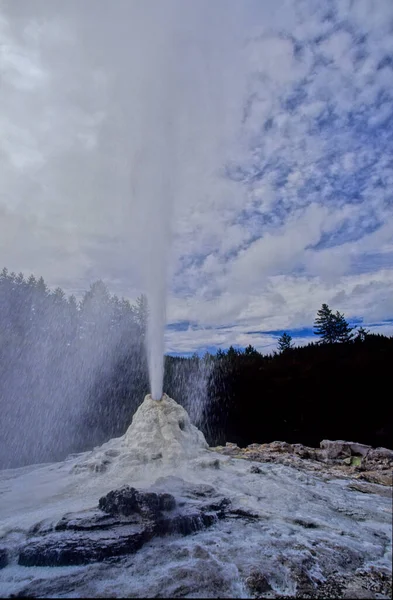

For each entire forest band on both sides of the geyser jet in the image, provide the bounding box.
[0,268,393,468]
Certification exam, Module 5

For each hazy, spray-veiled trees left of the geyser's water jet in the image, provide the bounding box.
[0,269,148,467]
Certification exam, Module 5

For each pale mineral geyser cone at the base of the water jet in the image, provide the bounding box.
[124,394,208,462]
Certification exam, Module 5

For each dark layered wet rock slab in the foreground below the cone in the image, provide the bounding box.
[18,486,230,567]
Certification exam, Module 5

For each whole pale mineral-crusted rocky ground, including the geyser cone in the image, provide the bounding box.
[0,398,393,599]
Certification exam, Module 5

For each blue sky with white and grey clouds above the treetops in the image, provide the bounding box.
[0,0,393,353]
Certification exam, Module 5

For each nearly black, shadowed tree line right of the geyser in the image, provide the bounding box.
[205,328,393,448]
